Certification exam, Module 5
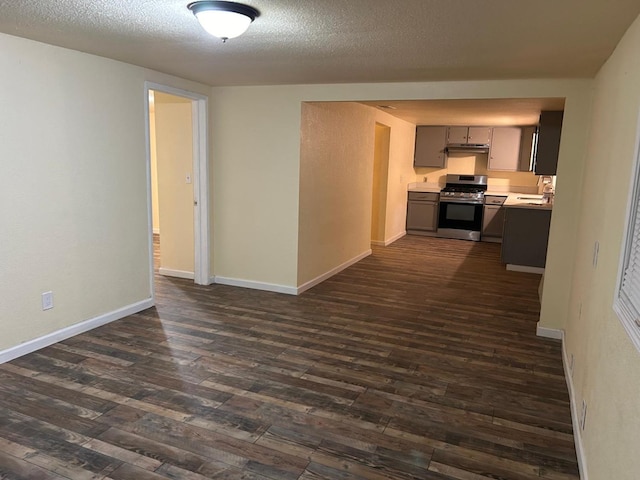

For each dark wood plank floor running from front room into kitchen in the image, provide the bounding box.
[0,237,578,480]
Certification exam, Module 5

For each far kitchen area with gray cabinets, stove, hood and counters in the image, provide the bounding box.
[406,110,563,273]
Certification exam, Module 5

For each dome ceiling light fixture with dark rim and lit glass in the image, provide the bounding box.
[187,1,260,42]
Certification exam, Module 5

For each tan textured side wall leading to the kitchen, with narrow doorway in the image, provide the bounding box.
[298,102,415,286]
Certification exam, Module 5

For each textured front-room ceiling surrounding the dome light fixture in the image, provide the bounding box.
[0,0,640,86]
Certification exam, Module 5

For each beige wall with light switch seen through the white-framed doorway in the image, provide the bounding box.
[154,92,194,275]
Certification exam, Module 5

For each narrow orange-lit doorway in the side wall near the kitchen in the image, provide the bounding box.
[371,123,391,245]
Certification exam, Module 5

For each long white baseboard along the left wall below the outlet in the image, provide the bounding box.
[0,298,154,364]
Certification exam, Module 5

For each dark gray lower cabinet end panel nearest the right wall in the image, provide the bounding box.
[502,207,551,268]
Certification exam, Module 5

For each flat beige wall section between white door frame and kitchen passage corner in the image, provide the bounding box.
[210,87,301,287]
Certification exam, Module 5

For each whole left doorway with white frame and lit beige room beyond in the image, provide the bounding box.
[145,83,211,291]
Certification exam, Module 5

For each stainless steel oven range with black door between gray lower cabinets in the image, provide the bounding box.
[437,175,487,242]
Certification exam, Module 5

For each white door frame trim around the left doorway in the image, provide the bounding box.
[144,81,210,288]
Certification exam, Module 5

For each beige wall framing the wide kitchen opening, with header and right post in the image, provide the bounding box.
[211,80,592,308]
